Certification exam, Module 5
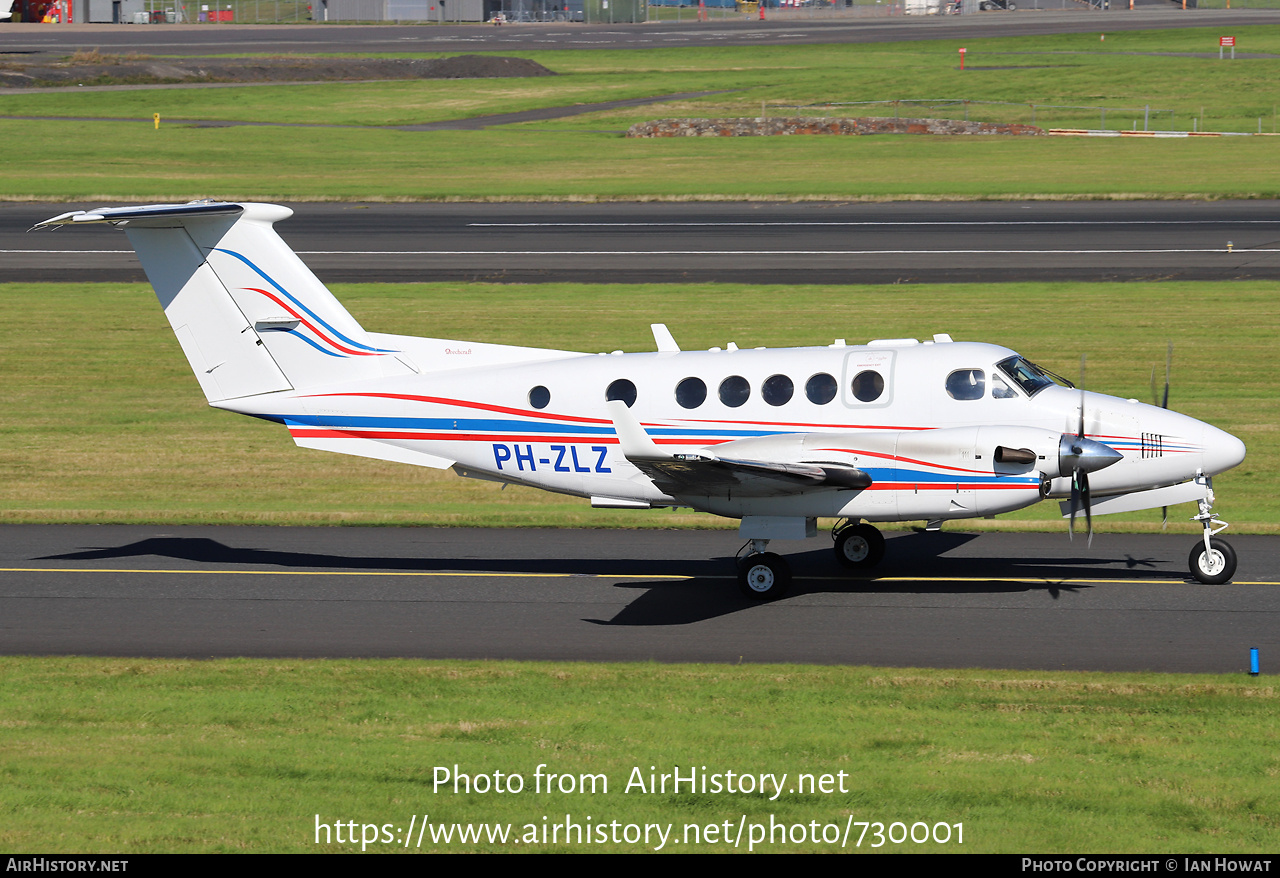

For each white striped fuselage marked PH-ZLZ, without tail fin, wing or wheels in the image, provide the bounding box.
[215,335,1244,521]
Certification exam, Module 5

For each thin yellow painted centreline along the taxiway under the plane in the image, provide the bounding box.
[0,567,1280,585]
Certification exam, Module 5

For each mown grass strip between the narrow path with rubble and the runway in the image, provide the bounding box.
[0,122,1280,201]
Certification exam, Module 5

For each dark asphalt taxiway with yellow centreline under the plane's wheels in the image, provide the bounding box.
[0,527,1280,673]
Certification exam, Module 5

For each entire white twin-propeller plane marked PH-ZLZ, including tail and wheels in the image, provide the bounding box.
[36,202,1244,599]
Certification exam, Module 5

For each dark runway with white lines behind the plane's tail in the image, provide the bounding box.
[10,201,1280,284]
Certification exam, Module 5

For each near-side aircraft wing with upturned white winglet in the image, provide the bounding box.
[609,401,872,497]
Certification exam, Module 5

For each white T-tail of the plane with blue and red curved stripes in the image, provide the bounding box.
[37,202,412,402]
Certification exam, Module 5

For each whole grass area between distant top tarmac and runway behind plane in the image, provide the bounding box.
[0,27,1280,201]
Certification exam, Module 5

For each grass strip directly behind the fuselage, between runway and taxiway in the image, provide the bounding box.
[0,282,1280,532]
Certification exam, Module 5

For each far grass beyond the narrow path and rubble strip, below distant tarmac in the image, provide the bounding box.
[15,26,1280,131]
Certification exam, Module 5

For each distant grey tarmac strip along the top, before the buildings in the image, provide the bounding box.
[0,11,1280,56]
